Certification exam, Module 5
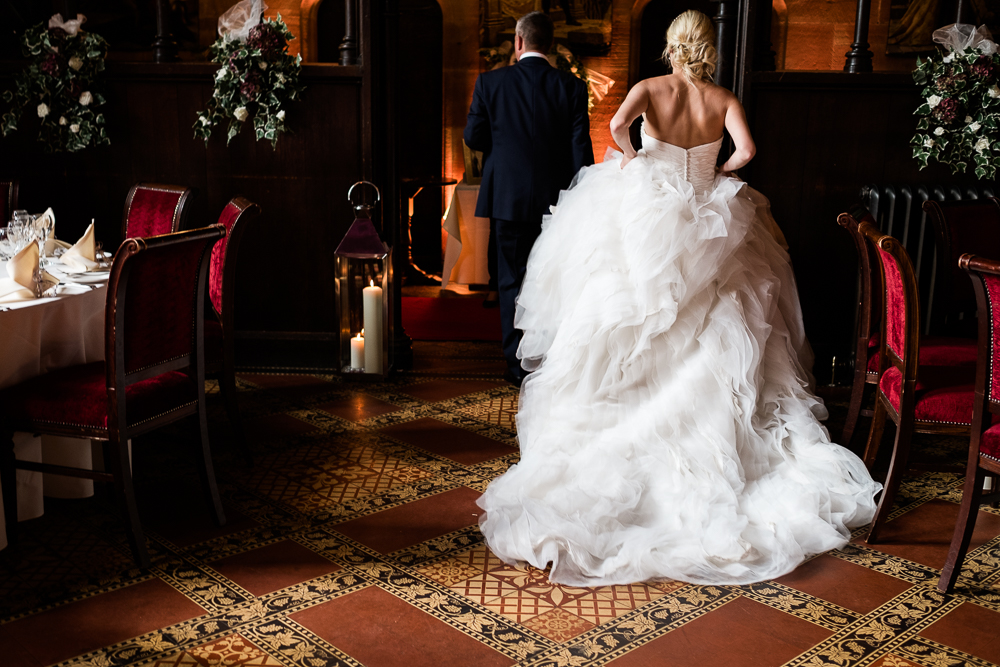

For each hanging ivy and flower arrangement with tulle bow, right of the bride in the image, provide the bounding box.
[910,24,1000,179]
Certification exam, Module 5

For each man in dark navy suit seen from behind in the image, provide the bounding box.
[465,12,594,386]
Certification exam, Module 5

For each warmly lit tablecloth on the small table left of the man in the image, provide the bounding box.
[441,181,490,287]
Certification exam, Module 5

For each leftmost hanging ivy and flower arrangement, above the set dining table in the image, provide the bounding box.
[0,14,111,153]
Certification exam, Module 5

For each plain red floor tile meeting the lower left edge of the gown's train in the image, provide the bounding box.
[335,486,481,554]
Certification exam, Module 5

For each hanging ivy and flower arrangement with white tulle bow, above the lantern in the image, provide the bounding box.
[194,1,304,148]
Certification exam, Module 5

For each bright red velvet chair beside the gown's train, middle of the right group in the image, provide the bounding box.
[859,221,975,543]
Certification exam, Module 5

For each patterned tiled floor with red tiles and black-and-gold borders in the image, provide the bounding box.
[0,343,1000,667]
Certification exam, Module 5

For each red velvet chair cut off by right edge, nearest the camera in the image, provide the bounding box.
[938,254,1000,593]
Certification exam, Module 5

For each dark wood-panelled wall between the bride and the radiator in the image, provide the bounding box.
[740,72,974,383]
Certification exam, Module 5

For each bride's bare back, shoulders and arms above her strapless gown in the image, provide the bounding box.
[611,73,755,172]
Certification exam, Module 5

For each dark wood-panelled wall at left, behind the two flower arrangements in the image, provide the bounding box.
[0,62,372,338]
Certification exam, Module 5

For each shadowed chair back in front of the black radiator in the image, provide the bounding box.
[923,197,1000,339]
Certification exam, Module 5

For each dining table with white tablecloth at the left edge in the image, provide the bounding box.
[0,258,110,549]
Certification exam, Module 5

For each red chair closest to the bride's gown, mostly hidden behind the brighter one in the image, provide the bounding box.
[837,205,977,448]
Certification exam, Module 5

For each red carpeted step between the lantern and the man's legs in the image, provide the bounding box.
[403,296,500,342]
